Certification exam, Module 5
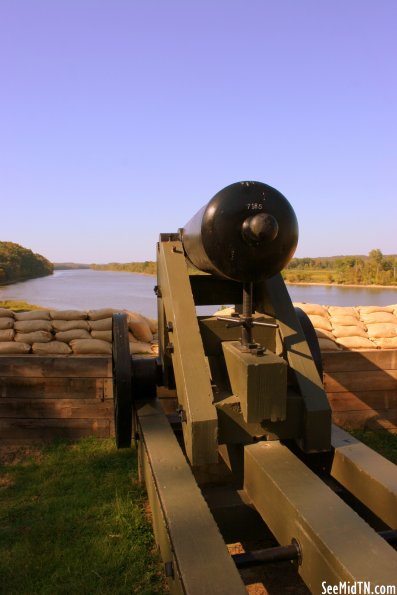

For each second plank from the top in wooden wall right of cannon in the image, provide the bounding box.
[324,369,397,393]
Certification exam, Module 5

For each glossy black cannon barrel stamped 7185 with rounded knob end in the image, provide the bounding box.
[181,182,298,282]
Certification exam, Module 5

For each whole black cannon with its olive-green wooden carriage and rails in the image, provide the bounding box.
[113,181,397,595]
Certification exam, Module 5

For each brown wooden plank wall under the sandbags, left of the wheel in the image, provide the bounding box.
[0,355,114,442]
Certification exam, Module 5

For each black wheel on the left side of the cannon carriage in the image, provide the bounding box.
[112,313,132,448]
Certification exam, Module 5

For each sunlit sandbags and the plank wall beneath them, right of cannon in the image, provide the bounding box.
[295,303,397,433]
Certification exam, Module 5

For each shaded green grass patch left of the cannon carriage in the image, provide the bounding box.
[0,439,165,595]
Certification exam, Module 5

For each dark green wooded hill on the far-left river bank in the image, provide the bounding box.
[0,242,54,284]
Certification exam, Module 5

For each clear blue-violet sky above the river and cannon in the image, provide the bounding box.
[0,0,397,262]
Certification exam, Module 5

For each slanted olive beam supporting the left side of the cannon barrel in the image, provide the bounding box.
[158,241,218,466]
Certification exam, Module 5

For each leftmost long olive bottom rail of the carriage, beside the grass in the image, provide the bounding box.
[138,404,246,595]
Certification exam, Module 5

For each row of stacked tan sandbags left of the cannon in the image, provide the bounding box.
[0,308,157,355]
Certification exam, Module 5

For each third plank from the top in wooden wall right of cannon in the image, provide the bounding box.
[328,390,397,411]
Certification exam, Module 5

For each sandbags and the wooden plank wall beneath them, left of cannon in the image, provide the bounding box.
[0,308,157,443]
